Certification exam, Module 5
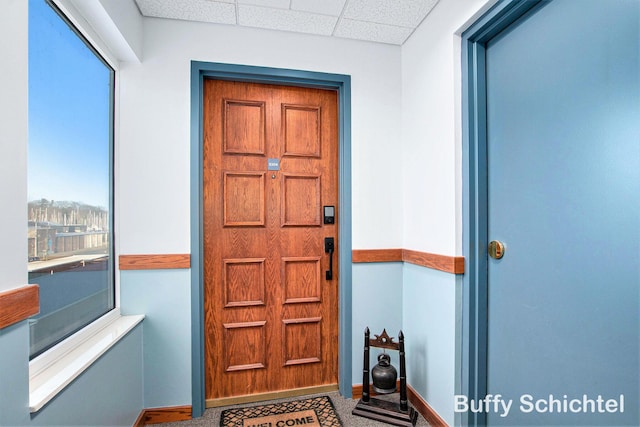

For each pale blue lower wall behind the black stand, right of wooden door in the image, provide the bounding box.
[352,262,460,425]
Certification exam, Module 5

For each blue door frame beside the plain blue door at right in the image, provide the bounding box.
[456,0,550,426]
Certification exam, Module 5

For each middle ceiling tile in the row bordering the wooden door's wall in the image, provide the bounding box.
[238,5,338,36]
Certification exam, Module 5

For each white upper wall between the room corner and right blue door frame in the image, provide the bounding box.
[401,0,495,255]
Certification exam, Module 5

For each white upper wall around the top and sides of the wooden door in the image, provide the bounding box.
[117,18,402,254]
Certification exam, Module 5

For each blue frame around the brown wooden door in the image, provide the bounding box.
[191,61,352,418]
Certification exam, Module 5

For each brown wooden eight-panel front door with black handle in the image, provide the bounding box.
[203,80,339,406]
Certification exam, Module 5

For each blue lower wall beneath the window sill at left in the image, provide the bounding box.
[0,321,143,427]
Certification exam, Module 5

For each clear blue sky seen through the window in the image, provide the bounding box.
[28,0,111,208]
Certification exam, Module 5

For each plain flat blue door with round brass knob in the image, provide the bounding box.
[484,0,640,426]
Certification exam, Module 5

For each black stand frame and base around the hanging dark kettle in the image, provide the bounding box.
[351,328,418,427]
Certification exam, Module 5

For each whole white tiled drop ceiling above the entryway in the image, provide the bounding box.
[135,0,438,45]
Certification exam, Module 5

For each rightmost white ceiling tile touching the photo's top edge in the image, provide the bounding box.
[343,0,438,28]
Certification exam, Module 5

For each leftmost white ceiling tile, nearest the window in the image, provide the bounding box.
[136,0,236,24]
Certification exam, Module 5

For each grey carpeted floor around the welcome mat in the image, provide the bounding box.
[156,391,429,427]
